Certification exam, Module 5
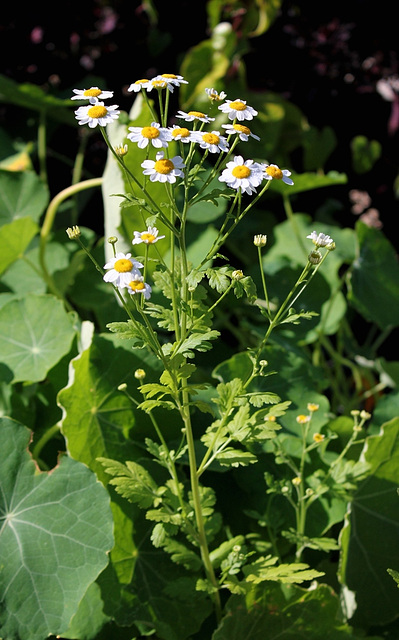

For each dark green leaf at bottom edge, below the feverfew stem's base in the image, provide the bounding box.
[212,583,378,640]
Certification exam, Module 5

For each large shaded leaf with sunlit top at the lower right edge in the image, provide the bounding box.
[340,418,399,627]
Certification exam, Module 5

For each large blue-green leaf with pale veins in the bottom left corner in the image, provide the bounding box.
[0,418,113,640]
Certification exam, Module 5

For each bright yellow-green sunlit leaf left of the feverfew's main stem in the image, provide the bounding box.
[58,334,162,480]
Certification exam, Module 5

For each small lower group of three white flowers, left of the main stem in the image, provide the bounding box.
[104,227,165,300]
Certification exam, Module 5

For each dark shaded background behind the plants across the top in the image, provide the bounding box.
[0,0,399,239]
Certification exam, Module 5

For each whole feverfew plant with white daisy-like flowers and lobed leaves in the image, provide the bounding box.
[67,74,344,623]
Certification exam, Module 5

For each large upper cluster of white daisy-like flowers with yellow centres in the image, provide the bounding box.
[72,73,294,195]
